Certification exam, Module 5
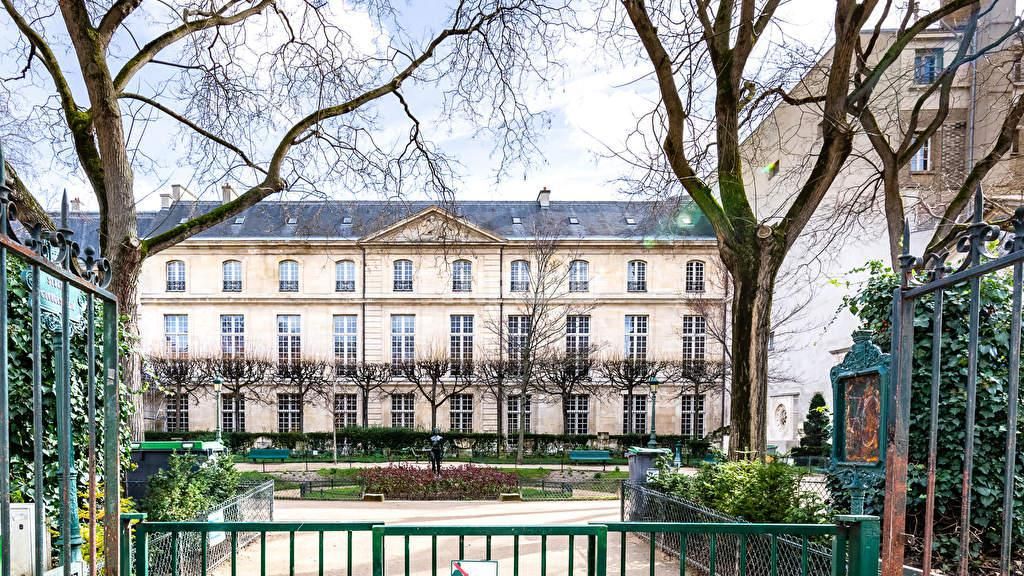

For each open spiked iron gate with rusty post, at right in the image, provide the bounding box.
[882,190,1024,576]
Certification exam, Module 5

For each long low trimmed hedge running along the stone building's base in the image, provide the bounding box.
[145,426,696,456]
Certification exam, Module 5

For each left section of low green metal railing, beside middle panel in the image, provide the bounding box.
[132,522,377,576]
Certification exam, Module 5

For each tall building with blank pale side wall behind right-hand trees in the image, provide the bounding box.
[743,0,1024,444]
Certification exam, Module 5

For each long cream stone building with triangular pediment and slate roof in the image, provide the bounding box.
[101,187,727,437]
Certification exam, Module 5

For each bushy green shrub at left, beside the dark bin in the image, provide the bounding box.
[141,454,240,522]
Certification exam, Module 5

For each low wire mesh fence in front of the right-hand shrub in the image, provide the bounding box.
[622,482,833,576]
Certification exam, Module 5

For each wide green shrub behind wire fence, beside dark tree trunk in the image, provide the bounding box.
[648,460,828,523]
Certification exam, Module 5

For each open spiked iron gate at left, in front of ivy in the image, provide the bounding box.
[0,145,120,576]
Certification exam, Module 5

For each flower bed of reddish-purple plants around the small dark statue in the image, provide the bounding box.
[359,464,519,500]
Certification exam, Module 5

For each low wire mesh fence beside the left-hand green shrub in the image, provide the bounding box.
[144,481,274,576]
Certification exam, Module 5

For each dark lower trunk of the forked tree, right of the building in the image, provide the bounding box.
[727,251,778,457]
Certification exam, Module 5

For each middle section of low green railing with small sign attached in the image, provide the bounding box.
[373,524,608,576]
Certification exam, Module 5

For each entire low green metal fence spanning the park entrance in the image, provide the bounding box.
[122,516,880,576]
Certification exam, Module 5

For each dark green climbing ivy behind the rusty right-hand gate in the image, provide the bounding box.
[847,262,1024,569]
